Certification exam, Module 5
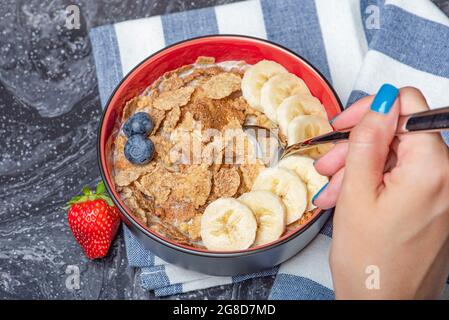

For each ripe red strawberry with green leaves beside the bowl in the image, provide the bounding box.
[67,181,120,259]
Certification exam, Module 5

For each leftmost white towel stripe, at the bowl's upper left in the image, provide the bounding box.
[114,16,165,75]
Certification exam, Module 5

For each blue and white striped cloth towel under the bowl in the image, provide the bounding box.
[90,0,449,299]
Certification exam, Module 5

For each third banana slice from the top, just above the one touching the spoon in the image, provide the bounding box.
[276,94,327,135]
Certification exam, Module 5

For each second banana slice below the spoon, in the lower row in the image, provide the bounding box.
[252,168,307,224]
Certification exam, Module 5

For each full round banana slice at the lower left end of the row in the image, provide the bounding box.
[200,198,257,251]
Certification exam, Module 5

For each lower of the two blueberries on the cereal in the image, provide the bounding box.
[125,134,154,164]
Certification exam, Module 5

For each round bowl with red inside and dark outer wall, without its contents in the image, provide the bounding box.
[98,35,342,275]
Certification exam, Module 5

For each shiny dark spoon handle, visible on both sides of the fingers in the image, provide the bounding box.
[282,107,449,158]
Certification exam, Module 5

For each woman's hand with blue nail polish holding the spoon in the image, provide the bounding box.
[314,85,449,299]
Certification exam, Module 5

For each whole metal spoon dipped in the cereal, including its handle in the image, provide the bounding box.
[243,107,449,164]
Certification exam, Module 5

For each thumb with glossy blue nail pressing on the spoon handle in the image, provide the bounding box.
[343,84,399,195]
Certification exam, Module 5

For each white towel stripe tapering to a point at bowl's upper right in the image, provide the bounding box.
[316,0,367,105]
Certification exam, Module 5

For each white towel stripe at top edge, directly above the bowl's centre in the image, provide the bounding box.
[215,0,267,39]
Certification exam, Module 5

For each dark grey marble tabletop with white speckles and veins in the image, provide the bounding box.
[0,0,449,299]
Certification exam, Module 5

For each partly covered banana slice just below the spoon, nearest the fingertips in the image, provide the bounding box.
[278,155,329,211]
